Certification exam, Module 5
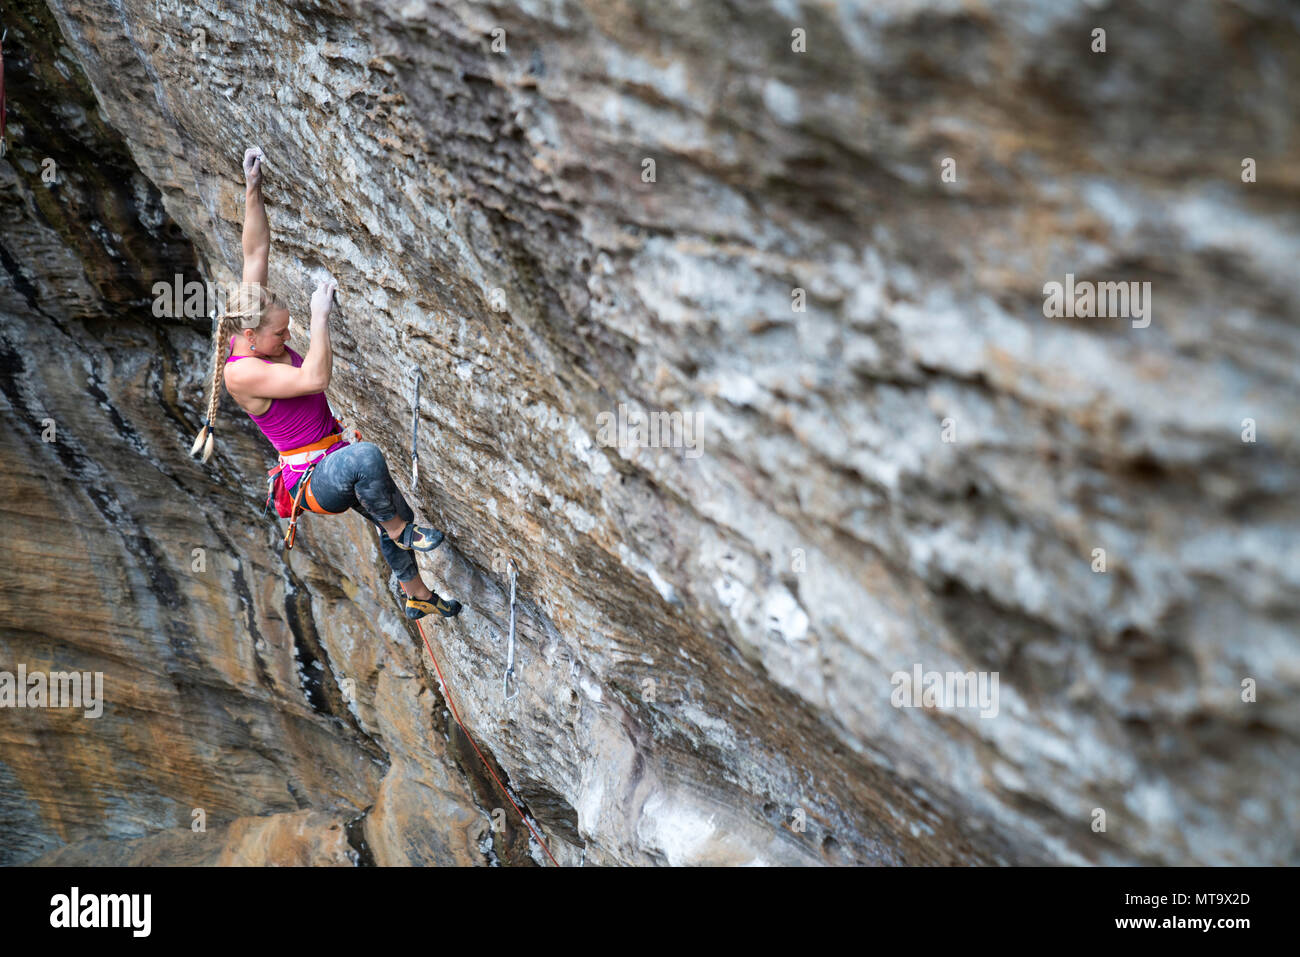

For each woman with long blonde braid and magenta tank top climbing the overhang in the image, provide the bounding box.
[192,141,460,619]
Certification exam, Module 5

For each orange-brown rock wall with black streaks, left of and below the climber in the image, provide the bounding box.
[0,0,527,863]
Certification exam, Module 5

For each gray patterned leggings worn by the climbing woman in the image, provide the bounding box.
[301,442,420,581]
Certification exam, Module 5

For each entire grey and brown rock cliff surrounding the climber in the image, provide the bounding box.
[0,0,1300,863]
